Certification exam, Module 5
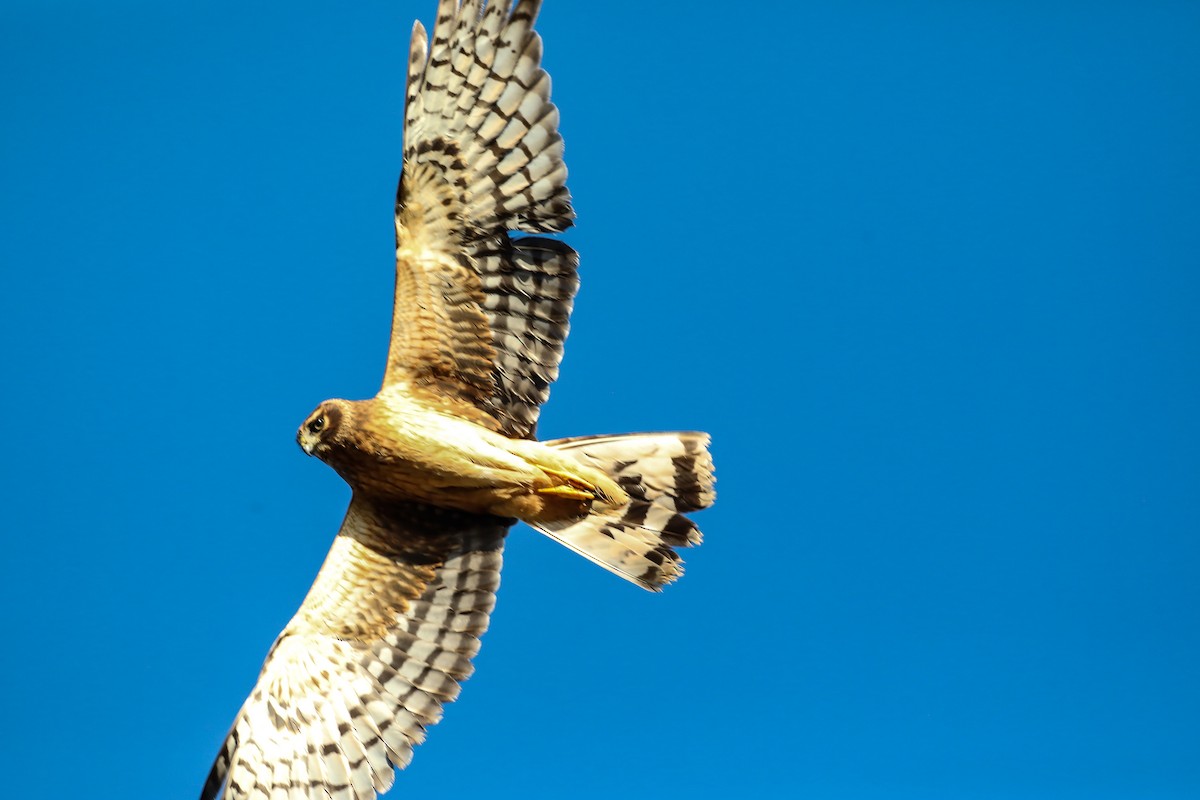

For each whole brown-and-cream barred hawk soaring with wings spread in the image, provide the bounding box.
[200,0,714,800]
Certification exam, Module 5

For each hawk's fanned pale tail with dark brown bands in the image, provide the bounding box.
[534,432,716,591]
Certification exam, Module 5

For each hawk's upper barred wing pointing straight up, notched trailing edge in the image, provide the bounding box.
[384,0,578,437]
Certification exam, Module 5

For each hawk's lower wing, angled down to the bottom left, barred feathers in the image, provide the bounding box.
[200,498,512,800]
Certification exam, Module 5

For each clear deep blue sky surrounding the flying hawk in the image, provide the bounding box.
[0,0,1200,799]
